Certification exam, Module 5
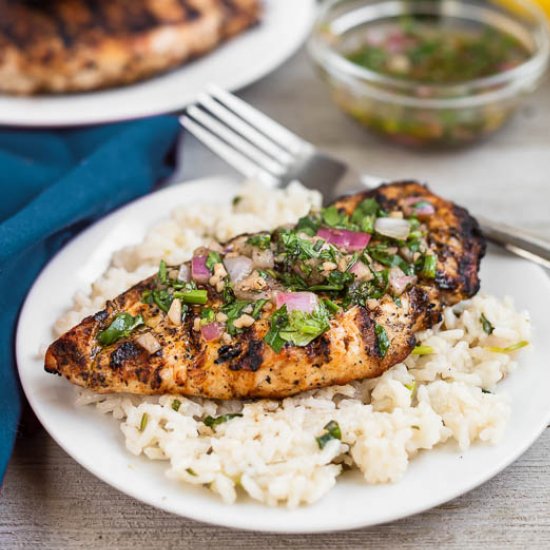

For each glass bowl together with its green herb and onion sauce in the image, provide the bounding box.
[309,0,550,146]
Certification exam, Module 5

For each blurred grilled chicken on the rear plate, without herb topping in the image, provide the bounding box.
[0,0,260,94]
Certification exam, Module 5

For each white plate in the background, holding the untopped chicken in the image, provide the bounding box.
[0,0,316,126]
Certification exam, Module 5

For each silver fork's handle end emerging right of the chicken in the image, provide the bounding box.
[476,216,550,269]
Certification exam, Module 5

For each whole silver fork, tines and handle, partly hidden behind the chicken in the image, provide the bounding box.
[180,87,550,269]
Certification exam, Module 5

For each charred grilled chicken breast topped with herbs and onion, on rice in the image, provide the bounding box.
[45,182,485,399]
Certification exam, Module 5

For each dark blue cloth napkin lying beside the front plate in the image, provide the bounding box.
[0,116,178,483]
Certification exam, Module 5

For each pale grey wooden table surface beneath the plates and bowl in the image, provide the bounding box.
[0,49,550,550]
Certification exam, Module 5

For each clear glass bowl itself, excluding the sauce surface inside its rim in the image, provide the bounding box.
[308,0,550,146]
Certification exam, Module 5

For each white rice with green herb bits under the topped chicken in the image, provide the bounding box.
[55,183,530,507]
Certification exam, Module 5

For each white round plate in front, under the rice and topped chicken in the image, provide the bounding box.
[16,177,550,532]
